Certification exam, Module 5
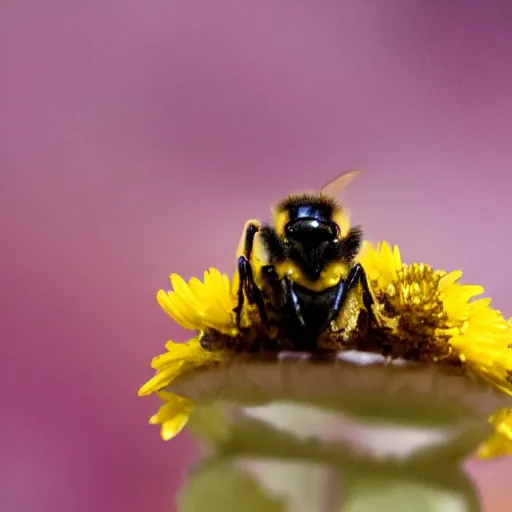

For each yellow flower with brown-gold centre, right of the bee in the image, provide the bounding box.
[359,242,512,395]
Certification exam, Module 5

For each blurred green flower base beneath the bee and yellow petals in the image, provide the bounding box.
[170,354,509,512]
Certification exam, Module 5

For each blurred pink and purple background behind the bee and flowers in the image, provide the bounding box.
[0,0,512,512]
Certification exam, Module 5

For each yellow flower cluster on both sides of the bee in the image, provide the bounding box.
[139,242,512,458]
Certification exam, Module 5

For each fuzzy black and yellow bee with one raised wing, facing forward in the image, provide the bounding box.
[234,169,378,350]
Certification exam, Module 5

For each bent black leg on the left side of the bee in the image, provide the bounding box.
[234,222,268,328]
